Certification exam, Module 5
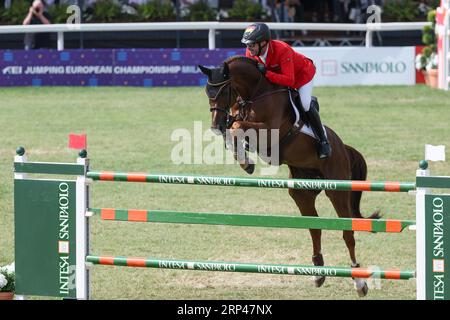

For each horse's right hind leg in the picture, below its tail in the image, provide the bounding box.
[326,191,368,297]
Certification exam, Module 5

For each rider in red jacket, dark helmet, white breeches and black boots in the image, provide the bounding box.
[241,23,331,159]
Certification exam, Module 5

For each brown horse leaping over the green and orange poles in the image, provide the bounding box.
[199,56,380,296]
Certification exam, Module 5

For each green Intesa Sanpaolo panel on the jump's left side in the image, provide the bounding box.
[14,180,76,298]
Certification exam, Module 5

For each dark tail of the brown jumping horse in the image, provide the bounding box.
[345,145,381,219]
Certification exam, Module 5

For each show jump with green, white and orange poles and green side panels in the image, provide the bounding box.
[14,148,450,300]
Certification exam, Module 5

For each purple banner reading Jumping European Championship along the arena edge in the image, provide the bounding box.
[0,49,245,87]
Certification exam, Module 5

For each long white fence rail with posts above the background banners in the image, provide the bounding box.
[0,22,431,50]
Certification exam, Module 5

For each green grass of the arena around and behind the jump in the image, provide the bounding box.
[0,86,450,299]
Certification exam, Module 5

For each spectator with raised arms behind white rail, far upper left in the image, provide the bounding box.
[23,0,51,50]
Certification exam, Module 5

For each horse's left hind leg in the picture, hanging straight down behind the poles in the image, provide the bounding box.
[289,189,325,287]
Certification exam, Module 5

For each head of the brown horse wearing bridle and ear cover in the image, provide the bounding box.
[198,62,237,135]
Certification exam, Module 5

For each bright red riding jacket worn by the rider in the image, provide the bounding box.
[245,40,316,89]
